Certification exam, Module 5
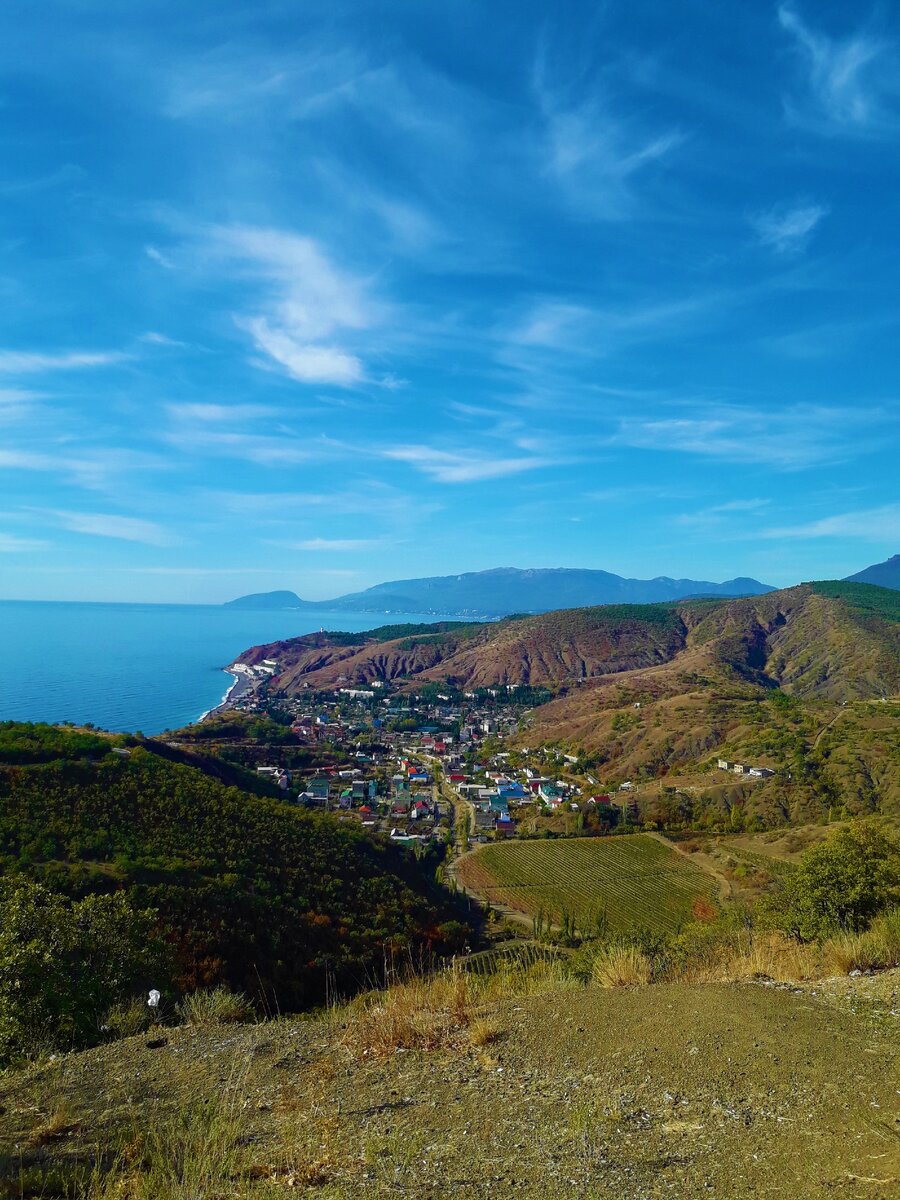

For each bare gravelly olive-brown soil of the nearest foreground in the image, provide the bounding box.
[0,971,900,1200]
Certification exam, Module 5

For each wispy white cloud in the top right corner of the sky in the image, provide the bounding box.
[778,4,900,132]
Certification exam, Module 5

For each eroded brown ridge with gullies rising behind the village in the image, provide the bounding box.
[241,584,900,701]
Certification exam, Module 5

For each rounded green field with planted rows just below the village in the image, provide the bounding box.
[456,834,715,934]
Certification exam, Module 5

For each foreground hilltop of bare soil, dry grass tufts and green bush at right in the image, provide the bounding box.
[0,824,900,1200]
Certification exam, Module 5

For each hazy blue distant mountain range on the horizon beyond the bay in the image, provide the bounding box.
[227,566,774,617]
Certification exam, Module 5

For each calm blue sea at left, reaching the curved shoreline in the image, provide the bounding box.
[0,600,451,734]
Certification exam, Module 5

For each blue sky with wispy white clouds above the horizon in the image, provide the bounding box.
[0,0,900,601]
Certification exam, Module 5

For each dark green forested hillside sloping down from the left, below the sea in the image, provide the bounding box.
[0,724,464,1009]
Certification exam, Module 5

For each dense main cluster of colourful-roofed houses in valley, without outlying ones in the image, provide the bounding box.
[222,662,648,841]
